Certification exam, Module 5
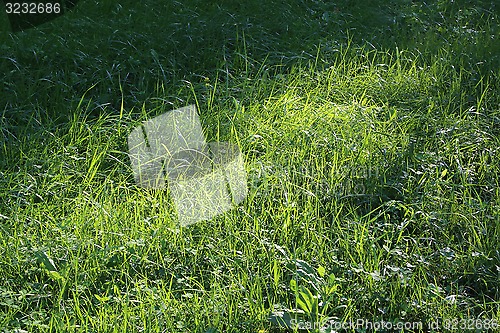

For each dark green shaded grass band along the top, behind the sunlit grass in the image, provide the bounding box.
[0,0,500,116]
